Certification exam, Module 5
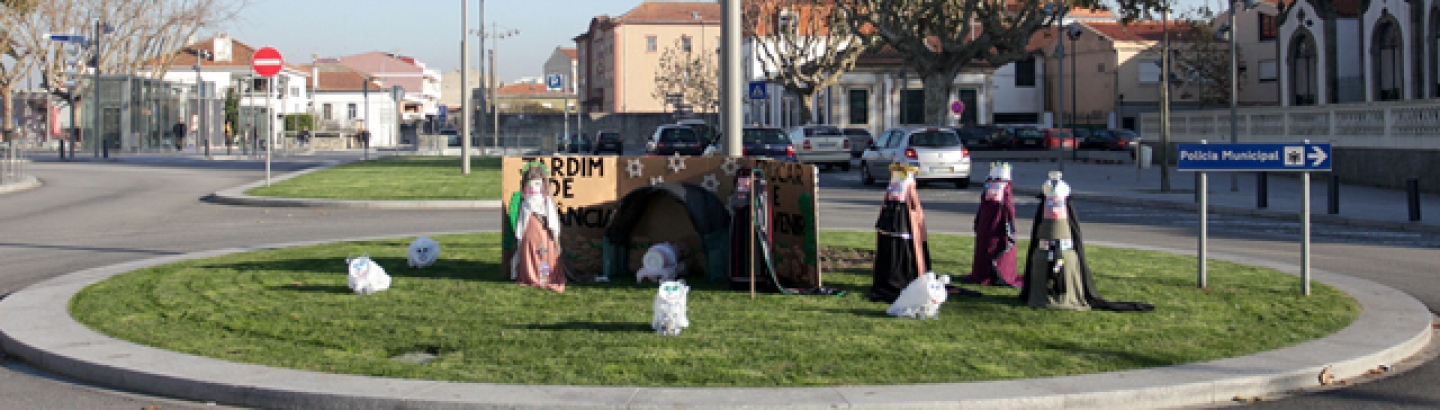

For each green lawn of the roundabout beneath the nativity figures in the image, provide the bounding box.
[71,232,1359,387]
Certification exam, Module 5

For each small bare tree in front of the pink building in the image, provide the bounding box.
[649,39,720,116]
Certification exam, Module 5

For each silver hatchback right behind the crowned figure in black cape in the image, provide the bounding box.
[860,127,971,188]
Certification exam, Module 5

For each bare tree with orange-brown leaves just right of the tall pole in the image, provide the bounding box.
[744,0,874,124]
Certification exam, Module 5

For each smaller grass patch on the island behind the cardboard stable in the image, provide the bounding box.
[246,157,500,200]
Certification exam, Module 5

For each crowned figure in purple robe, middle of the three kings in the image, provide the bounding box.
[960,163,1022,288]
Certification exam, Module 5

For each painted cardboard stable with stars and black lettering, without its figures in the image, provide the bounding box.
[500,155,821,288]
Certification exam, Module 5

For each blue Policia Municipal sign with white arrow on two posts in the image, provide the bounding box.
[1175,142,1331,171]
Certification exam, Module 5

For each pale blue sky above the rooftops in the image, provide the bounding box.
[224,0,1223,81]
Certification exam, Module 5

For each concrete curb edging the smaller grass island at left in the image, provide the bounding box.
[209,164,501,210]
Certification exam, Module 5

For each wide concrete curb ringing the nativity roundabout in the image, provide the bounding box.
[0,231,1433,409]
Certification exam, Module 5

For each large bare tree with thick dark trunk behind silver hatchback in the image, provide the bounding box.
[835,0,1168,124]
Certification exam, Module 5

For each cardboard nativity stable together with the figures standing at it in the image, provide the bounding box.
[501,155,838,292]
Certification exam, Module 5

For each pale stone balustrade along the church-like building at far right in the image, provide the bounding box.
[1140,101,1440,150]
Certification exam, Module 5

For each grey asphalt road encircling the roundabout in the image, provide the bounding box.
[0,154,1440,409]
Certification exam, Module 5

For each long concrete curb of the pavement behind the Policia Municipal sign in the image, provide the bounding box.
[1012,187,1440,233]
